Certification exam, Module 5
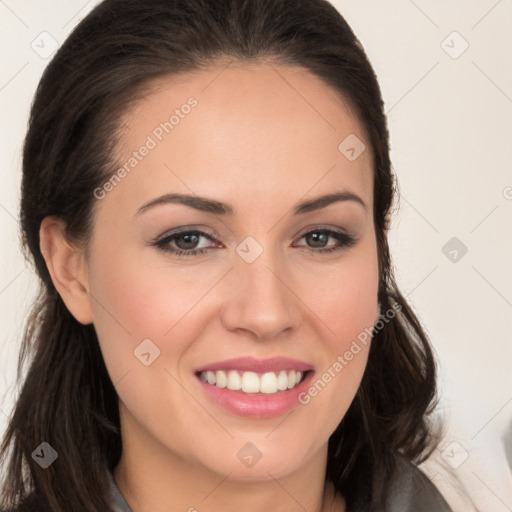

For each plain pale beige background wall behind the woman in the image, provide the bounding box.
[0,0,512,512]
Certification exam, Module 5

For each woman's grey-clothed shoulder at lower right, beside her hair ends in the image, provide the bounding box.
[386,457,452,512]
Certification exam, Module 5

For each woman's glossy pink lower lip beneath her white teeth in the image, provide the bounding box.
[196,370,314,418]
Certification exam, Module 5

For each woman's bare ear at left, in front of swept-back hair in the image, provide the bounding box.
[39,216,92,325]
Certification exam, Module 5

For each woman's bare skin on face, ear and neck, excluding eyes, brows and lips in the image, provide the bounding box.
[41,63,379,512]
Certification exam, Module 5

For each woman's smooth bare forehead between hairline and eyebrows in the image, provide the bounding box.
[106,64,373,216]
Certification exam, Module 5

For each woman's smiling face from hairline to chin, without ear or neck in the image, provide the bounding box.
[87,64,378,479]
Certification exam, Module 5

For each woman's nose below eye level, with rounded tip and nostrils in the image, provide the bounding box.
[222,251,301,340]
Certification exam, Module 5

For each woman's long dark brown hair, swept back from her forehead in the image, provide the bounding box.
[0,0,436,512]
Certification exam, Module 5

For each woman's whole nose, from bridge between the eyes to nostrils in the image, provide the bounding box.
[224,237,299,339]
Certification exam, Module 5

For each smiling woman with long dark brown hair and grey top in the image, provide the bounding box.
[2,0,449,512]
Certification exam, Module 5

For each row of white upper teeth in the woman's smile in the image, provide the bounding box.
[199,370,303,394]
